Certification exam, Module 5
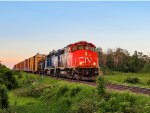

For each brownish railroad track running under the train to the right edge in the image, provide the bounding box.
[50,76,150,96]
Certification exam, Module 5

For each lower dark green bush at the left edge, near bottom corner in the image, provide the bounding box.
[0,85,8,108]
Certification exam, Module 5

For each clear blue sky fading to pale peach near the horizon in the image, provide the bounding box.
[0,1,150,68]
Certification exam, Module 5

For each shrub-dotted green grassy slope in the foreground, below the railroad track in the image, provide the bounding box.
[5,74,150,113]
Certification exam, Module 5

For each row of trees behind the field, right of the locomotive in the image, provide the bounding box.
[98,48,150,73]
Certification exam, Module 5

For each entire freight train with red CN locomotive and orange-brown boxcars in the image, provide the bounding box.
[14,41,99,80]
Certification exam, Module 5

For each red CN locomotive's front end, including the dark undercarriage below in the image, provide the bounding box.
[68,41,99,80]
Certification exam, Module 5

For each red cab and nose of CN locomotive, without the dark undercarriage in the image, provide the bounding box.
[71,43,98,68]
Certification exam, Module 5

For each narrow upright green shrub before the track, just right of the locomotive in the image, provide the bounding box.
[96,76,106,96]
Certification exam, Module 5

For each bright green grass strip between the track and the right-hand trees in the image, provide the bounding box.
[104,72,150,88]
